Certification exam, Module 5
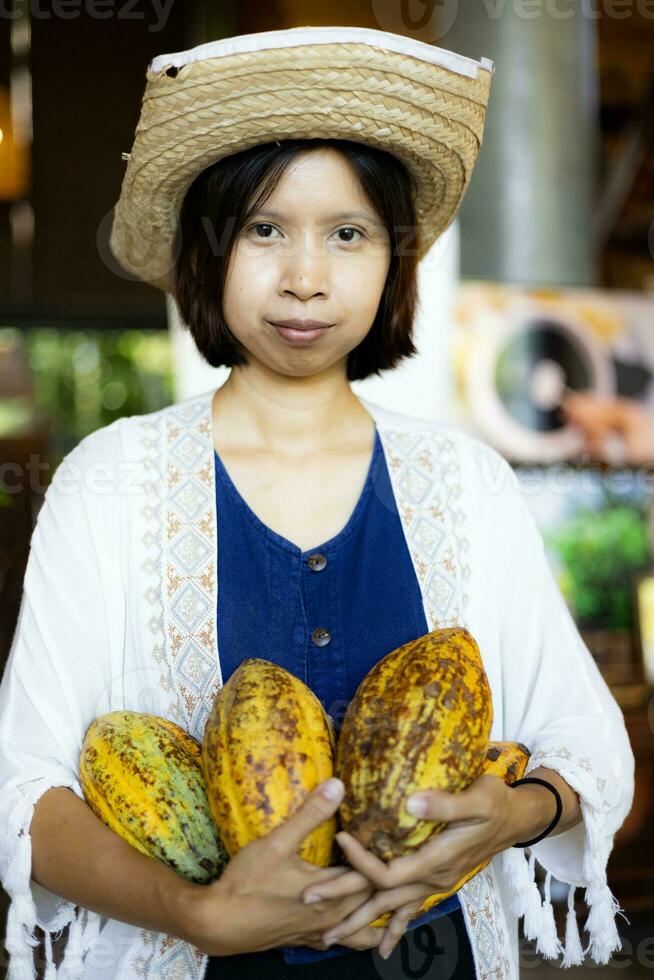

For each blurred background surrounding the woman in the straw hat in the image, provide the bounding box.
[0,0,654,977]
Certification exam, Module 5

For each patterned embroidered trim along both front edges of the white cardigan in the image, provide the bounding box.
[129,392,516,980]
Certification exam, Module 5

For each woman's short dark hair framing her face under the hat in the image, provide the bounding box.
[173,139,419,381]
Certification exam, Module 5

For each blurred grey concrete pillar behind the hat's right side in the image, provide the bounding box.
[434,0,599,285]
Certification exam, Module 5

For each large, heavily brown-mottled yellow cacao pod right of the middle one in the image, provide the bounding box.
[336,627,493,861]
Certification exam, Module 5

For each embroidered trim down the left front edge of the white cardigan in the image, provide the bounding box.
[127,393,220,980]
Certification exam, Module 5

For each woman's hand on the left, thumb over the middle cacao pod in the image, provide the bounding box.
[181,780,385,956]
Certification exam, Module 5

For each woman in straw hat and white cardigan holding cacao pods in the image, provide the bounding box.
[0,28,633,980]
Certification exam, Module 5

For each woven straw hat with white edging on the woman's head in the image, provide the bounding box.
[109,27,493,290]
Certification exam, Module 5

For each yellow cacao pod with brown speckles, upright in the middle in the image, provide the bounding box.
[202,657,337,867]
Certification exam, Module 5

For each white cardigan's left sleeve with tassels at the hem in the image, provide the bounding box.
[0,437,108,980]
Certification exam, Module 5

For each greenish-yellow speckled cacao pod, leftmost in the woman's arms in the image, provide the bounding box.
[79,711,229,884]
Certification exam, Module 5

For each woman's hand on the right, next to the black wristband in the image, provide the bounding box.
[306,774,515,955]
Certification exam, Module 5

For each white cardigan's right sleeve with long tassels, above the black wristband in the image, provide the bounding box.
[480,454,635,966]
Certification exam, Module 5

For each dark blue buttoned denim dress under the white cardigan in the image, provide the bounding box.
[214,428,461,963]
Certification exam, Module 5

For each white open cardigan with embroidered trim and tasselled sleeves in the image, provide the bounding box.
[0,390,634,980]
